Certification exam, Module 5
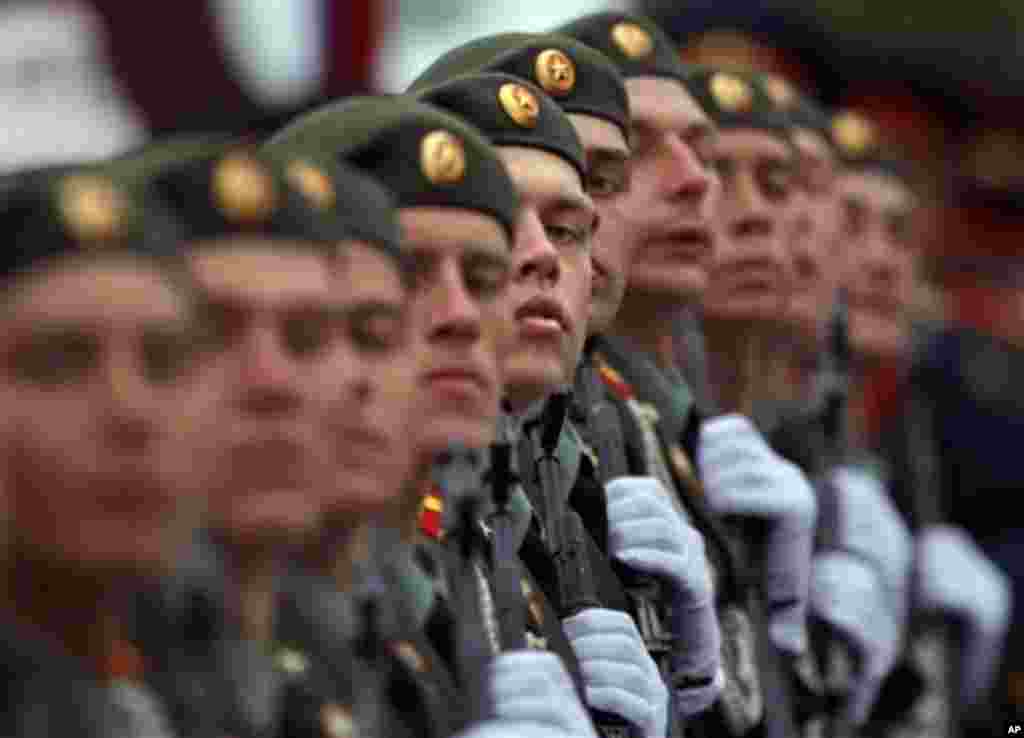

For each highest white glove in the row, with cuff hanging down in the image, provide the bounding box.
[697,415,817,654]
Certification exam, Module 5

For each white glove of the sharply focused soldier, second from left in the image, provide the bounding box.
[562,608,669,738]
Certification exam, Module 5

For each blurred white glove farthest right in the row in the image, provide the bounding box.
[918,525,1012,704]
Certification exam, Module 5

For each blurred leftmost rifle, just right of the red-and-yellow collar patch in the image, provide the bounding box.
[434,444,500,723]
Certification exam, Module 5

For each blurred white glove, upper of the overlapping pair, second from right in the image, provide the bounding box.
[831,467,913,623]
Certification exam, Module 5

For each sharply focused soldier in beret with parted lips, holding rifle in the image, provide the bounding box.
[411,74,692,735]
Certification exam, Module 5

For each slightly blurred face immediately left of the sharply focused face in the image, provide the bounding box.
[399,208,510,454]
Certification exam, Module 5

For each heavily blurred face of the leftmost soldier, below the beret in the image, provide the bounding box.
[0,259,210,573]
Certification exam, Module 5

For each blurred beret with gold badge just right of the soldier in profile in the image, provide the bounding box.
[688,67,793,140]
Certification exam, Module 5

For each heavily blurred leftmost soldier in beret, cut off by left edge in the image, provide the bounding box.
[0,166,208,736]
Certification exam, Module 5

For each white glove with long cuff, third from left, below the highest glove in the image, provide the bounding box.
[606,477,722,720]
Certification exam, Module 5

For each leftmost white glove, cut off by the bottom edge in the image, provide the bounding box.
[489,651,597,738]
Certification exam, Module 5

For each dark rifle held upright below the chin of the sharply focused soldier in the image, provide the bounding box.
[527,392,642,738]
